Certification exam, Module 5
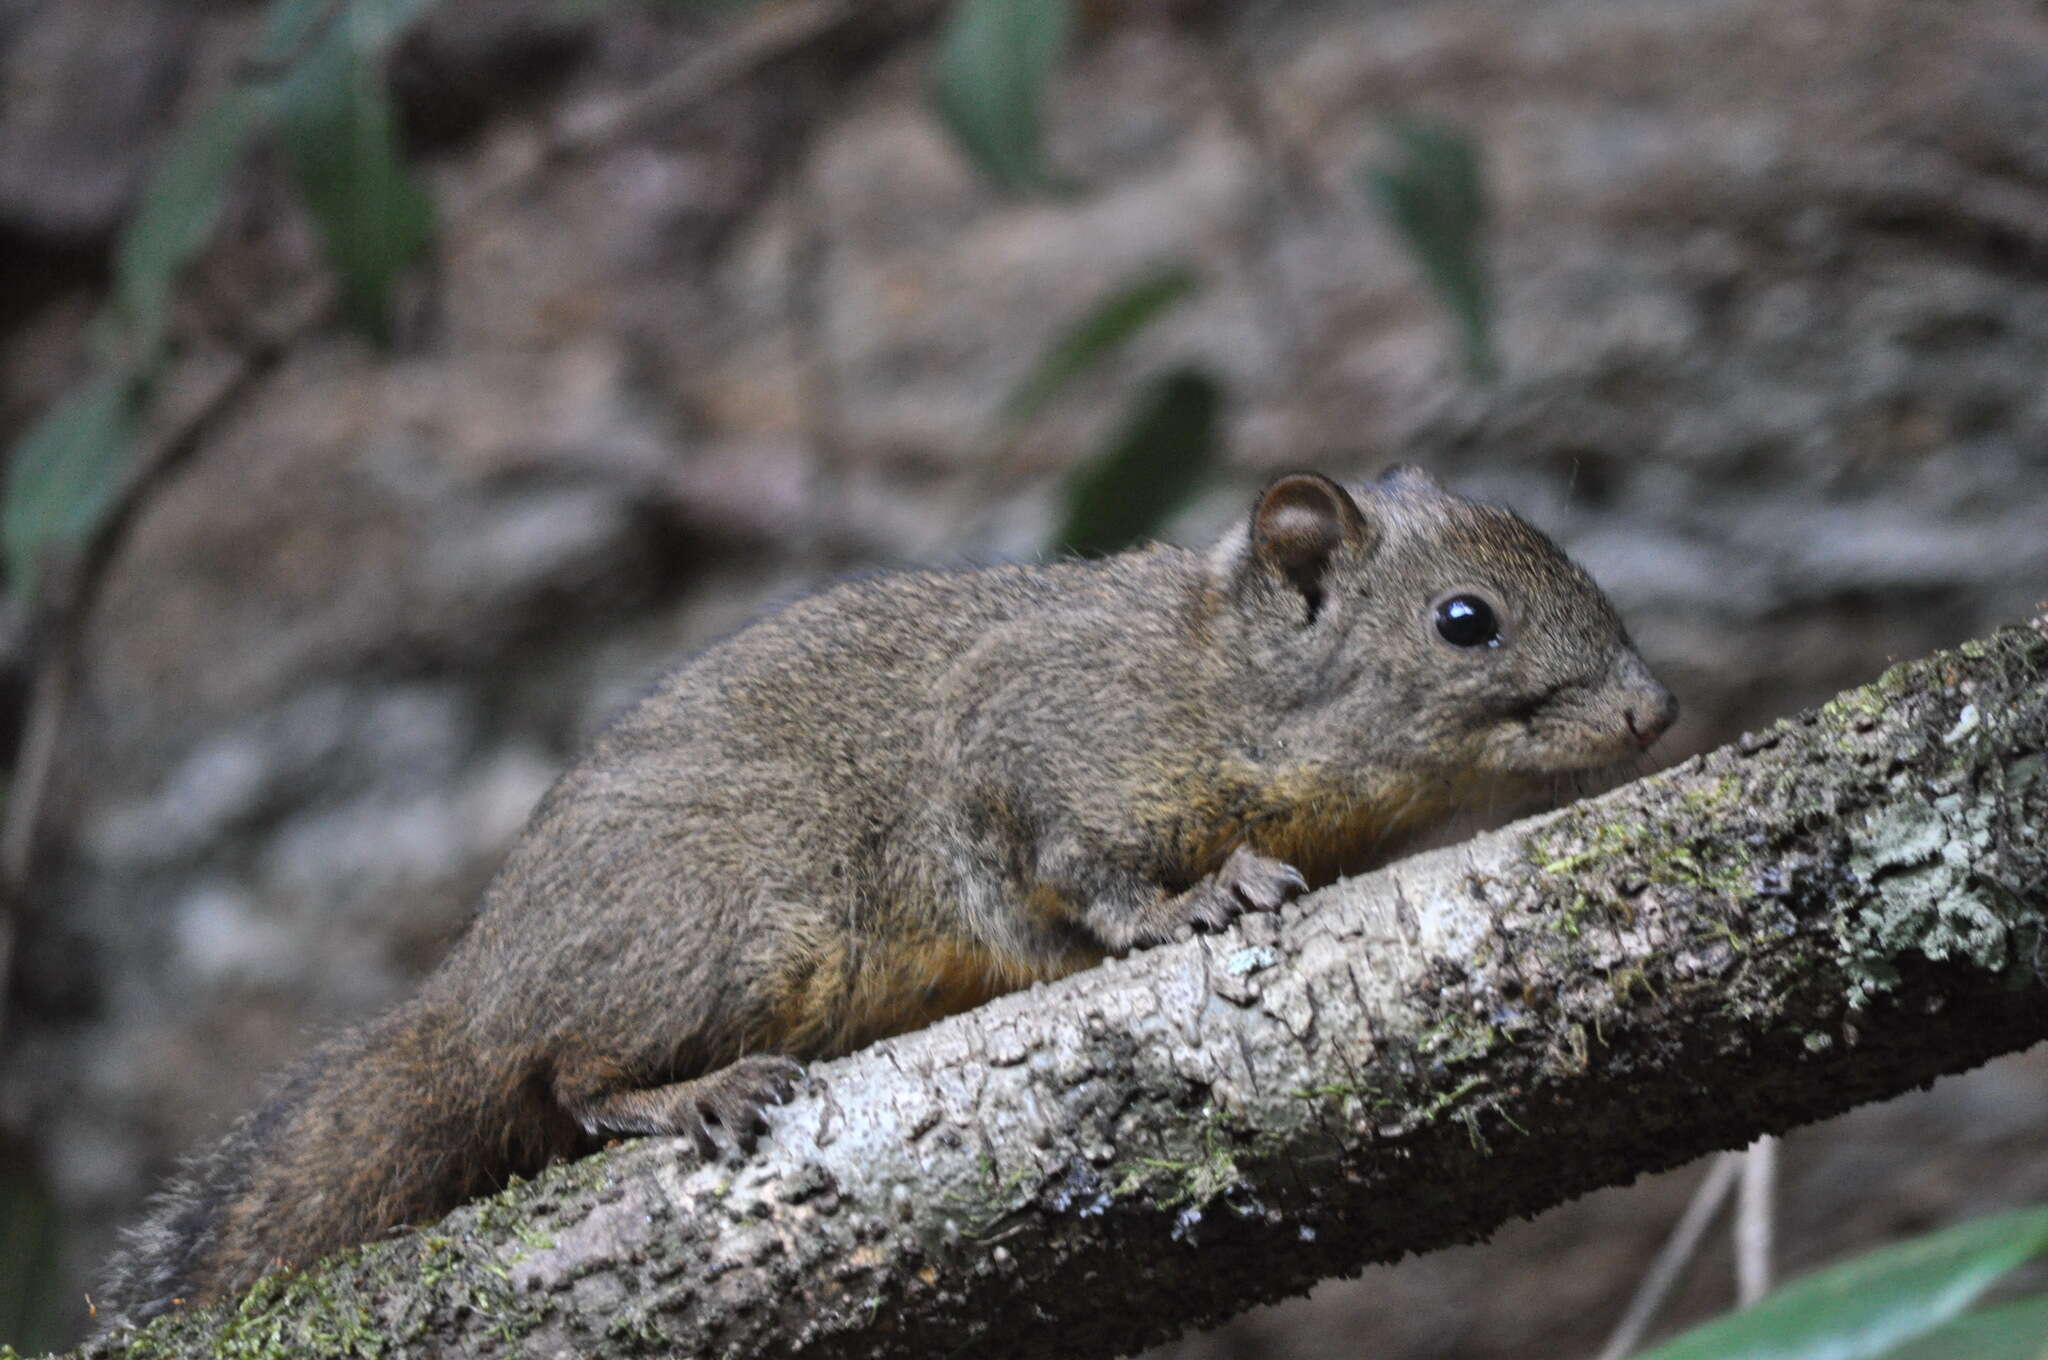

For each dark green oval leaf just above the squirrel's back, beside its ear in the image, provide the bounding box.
[1053,367,1223,557]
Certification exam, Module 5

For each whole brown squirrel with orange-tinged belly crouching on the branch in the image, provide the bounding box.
[96,467,1677,1321]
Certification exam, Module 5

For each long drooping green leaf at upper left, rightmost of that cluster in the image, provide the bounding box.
[272,0,434,342]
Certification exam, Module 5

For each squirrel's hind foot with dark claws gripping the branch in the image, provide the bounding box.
[555,1053,803,1157]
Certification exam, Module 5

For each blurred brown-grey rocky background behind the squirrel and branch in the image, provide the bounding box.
[0,0,2048,1360]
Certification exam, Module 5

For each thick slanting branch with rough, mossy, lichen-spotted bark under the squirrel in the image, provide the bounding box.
[68,617,2048,1356]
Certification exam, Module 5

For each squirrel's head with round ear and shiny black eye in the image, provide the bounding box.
[1210,467,1677,776]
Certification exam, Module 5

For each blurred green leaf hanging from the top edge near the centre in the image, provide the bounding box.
[932,0,1073,190]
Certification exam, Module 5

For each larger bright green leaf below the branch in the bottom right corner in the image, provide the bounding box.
[1638,1206,2048,1360]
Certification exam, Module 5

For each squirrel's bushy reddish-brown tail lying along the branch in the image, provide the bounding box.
[100,1000,573,1327]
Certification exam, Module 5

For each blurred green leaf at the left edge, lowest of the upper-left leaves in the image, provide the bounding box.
[0,373,137,600]
